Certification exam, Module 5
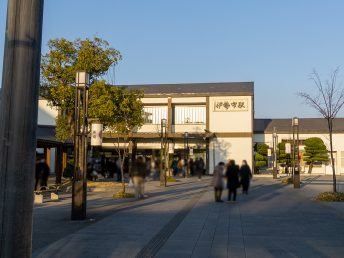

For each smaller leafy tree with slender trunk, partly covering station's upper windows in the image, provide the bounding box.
[89,81,144,193]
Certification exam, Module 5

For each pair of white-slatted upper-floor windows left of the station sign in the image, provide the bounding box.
[143,106,206,124]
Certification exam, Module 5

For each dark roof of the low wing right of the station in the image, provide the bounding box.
[253,118,344,134]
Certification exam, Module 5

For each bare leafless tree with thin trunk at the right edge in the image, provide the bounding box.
[298,68,344,192]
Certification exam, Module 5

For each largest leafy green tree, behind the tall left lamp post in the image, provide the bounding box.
[41,37,122,141]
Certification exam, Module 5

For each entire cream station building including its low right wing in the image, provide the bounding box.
[37,82,344,174]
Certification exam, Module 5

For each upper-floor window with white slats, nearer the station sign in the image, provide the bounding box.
[173,106,206,124]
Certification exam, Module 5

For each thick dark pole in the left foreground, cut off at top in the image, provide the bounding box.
[0,0,43,257]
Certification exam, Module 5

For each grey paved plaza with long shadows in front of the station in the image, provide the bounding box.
[33,175,344,258]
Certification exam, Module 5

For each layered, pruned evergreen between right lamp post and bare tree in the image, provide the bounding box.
[303,137,329,174]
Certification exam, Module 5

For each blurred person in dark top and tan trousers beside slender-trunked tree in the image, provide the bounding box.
[130,157,146,199]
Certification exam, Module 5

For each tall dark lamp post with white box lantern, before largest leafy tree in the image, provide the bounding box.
[71,71,89,220]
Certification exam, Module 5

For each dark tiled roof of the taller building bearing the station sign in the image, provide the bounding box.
[122,82,254,95]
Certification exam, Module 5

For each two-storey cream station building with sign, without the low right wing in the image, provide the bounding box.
[37,82,254,173]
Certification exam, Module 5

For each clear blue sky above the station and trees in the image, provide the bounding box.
[0,0,344,118]
